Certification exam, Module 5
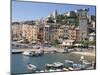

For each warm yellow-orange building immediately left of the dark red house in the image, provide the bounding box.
[22,24,38,42]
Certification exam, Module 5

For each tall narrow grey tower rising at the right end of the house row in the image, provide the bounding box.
[78,9,89,41]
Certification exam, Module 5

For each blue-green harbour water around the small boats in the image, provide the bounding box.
[11,53,95,74]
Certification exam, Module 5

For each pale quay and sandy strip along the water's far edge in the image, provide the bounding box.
[11,47,95,56]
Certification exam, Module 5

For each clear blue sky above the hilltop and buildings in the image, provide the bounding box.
[12,1,96,22]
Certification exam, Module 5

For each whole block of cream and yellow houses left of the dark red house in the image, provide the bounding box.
[12,24,39,42]
